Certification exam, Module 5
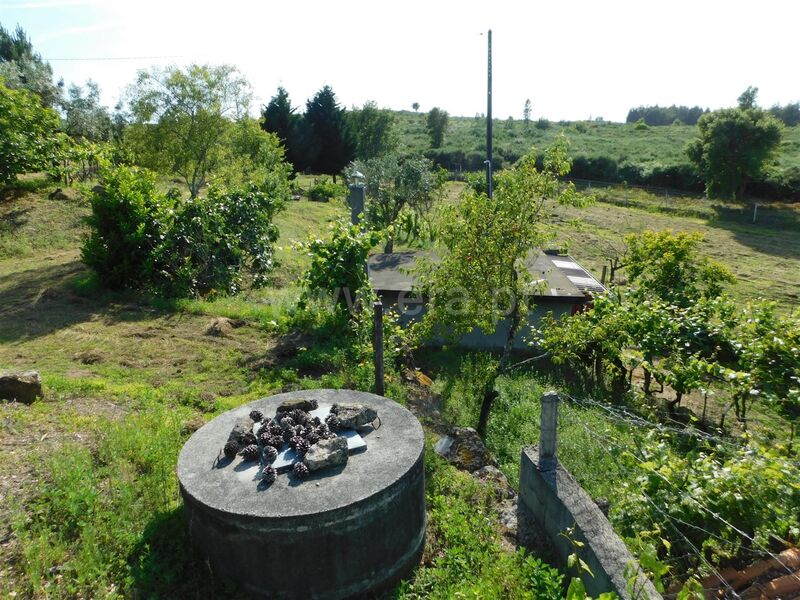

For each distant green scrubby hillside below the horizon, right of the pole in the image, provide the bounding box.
[395,111,800,200]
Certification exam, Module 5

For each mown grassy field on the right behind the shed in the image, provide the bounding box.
[553,188,800,310]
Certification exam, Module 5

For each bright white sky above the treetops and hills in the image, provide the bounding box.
[0,0,800,121]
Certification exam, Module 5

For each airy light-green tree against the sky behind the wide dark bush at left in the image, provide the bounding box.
[128,65,251,198]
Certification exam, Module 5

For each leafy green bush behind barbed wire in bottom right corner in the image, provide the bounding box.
[614,435,800,567]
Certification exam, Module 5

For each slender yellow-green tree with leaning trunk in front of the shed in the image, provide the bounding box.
[415,140,582,433]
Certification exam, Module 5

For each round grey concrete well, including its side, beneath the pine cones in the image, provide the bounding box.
[178,390,425,598]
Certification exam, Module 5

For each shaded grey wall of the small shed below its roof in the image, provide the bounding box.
[380,292,574,350]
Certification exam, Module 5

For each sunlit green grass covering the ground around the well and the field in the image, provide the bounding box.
[0,164,800,598]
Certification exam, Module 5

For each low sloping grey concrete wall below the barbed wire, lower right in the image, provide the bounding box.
[519,446,661,600]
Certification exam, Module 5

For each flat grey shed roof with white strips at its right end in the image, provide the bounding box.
[367,252,605,300]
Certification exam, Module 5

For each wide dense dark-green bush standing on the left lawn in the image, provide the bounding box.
[82,165,289,296]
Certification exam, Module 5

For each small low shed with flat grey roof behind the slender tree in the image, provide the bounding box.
[367,250,605,349]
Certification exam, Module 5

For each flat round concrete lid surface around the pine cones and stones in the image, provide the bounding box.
[178,389,424,519]
